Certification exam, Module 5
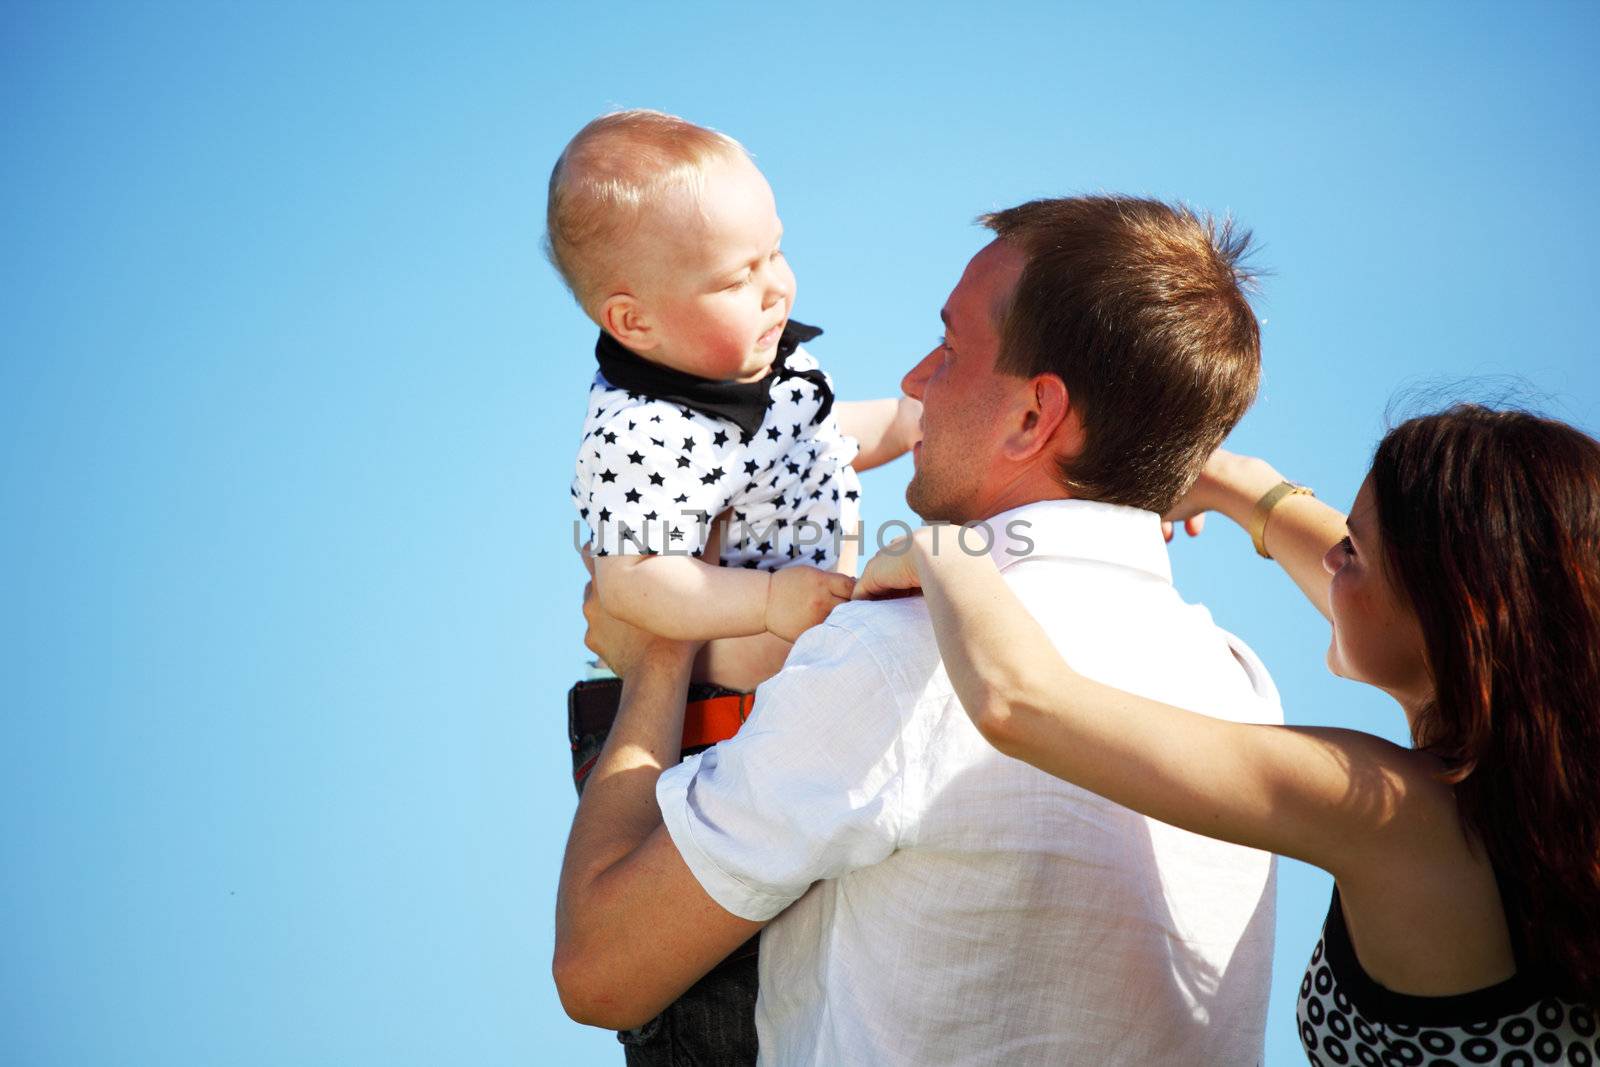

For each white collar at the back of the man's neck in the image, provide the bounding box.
[974,501,1173,582]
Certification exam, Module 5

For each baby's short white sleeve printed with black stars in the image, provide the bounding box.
[576,405,728,555]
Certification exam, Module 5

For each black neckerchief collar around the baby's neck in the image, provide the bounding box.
[595,318,834,442]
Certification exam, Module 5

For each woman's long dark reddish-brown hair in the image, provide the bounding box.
[1371,405,1600,1003]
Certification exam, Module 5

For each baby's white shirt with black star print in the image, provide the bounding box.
[571,342,861,571]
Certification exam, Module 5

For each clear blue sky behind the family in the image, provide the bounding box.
[0,0,1600,1065]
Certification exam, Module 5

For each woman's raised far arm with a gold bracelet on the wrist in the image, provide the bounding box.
[1166,448,1344,617]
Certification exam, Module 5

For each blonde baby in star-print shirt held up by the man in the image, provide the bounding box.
[547,110,920,689]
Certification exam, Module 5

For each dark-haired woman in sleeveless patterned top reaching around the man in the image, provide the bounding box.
[858,406,1600,1064]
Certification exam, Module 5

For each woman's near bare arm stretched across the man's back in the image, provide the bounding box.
[876,530,1448,873]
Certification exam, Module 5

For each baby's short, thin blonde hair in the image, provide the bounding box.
[544,107,749,318]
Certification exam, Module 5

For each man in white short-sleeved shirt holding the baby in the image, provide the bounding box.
[555,197,1280,1065]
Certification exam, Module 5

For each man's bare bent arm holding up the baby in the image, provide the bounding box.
[554,639,763,1030]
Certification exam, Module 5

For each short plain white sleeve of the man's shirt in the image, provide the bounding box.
[656,624,906,921]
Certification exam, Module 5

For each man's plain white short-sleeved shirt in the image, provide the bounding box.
[656,501,1282,1067]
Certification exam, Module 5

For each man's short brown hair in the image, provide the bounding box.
[979,197,1261,512]
